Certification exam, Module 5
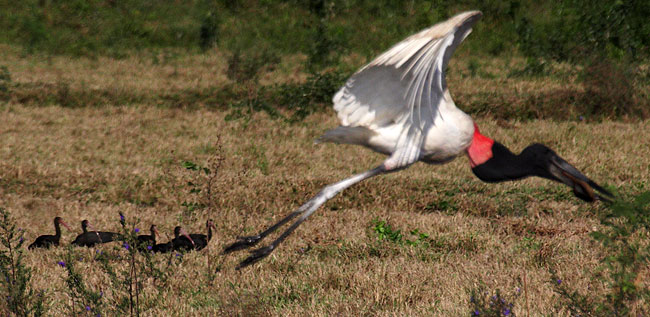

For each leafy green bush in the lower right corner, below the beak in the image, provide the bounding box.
[552,192,650,316]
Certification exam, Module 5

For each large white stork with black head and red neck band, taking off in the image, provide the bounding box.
[224,11,613,269]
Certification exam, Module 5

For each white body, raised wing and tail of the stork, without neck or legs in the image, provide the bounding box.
[319,11,481,170]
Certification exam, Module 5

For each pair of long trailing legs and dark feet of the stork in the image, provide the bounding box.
[224,164,384,269]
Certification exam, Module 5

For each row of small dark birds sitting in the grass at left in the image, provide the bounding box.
[29,217,216,253]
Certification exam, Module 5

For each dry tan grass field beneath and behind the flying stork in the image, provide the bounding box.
[0,47,650,316]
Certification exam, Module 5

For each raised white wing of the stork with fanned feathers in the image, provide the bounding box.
[333,11,482,129]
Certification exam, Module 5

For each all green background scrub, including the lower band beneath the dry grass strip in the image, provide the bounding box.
[0,0,650,119]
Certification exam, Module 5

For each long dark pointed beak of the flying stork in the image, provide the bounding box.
[549,155,614,202]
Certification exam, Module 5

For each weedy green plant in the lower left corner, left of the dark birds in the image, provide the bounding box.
[0,207,45,316]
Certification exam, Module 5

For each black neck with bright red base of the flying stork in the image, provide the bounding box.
[467,123,546,182]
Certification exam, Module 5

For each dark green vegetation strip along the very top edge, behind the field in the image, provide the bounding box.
[0,0,650,61]
